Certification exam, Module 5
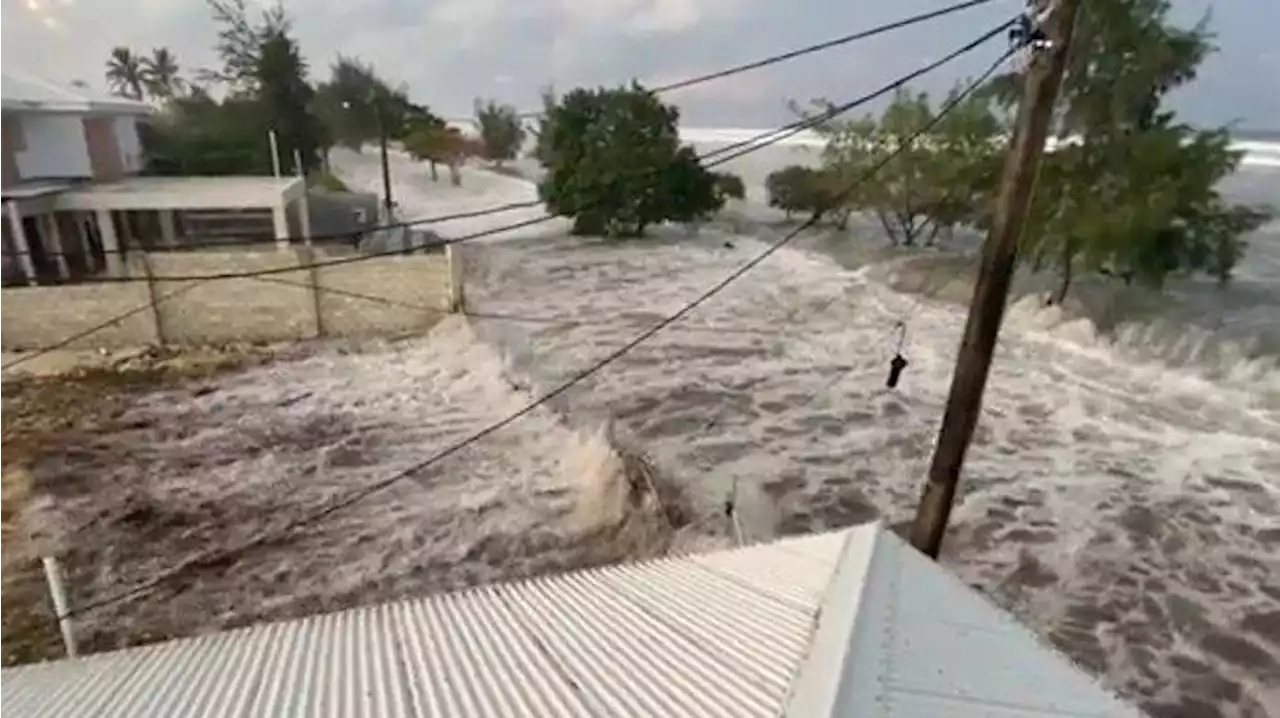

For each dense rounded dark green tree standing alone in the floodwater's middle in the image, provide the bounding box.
[539,83,723,237]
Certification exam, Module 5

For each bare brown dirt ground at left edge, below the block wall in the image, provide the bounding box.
[0,347,298,666]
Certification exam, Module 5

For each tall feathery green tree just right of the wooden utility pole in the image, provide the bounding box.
[993,0,1267,302]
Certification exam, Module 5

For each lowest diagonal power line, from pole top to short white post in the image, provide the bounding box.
[62,23,1014,614]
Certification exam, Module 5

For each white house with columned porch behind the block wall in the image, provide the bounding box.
[0,68,311,285]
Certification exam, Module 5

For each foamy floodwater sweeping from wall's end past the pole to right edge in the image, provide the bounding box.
[340,137,1280,718]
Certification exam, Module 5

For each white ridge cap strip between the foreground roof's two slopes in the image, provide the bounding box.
[782,521,884,718]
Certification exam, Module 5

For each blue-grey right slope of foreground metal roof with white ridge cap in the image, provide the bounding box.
[786,532,1143,718]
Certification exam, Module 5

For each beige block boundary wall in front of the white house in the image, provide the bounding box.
[0,250,460,349]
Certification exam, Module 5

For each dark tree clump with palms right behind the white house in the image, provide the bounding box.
[135,0,444,175]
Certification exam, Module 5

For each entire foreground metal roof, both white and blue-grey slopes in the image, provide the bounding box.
[0,525,1140,718]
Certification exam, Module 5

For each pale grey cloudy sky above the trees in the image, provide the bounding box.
[0,0,1280,128]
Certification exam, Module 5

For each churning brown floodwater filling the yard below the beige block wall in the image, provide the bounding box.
[29,317,680,650]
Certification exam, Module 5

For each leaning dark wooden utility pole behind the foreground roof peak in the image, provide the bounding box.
[911,0,1082,559]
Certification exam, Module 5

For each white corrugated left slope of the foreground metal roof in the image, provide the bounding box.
[0,534,844,718]
